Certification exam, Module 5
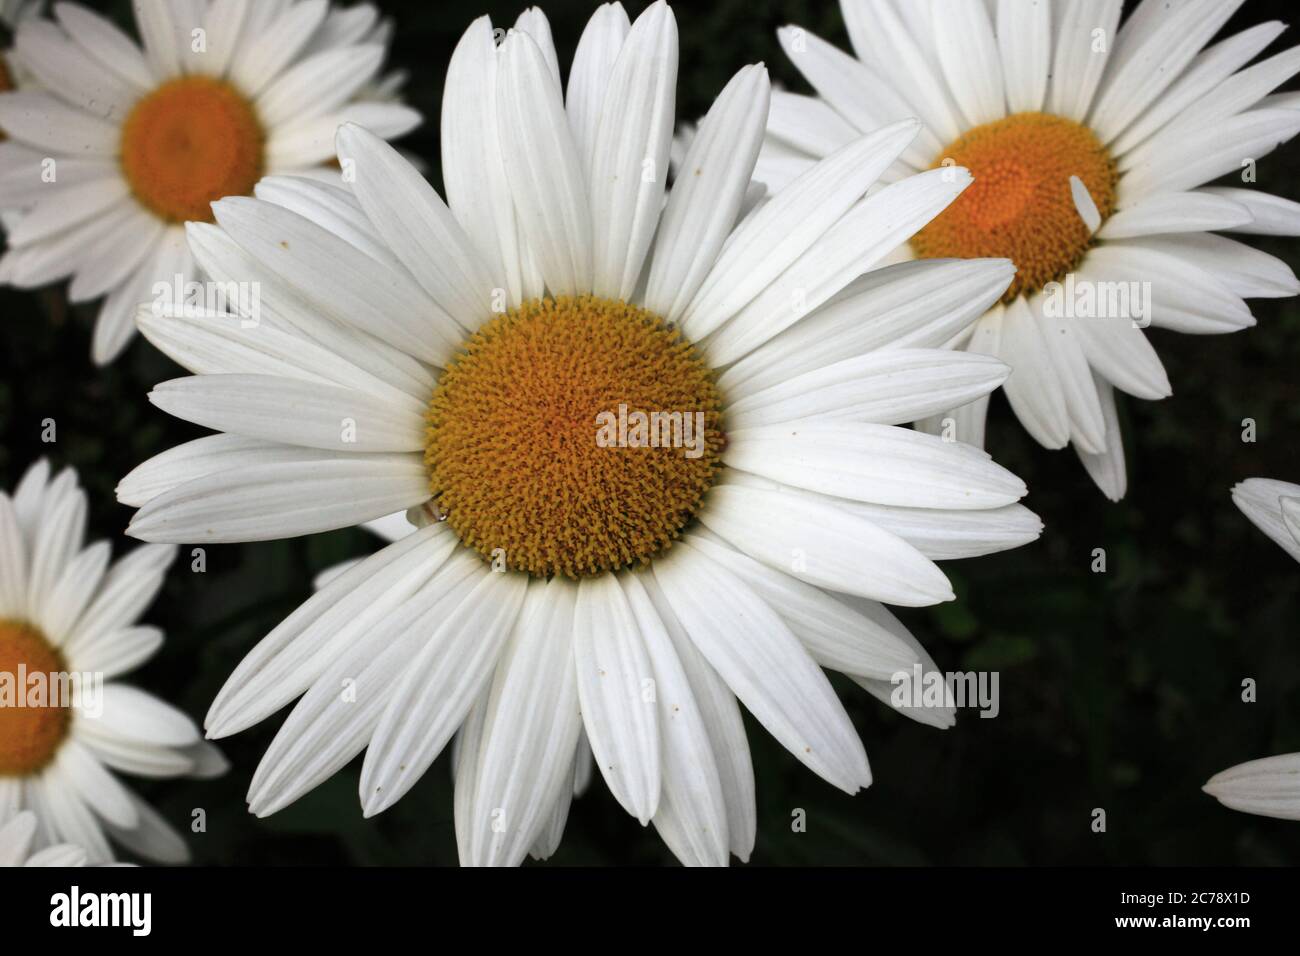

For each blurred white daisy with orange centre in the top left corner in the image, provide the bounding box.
[0,0,420,364]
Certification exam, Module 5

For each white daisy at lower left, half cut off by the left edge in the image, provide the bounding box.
[0,460,225,864]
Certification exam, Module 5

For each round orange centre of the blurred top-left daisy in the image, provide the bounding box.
[122,77,267,222]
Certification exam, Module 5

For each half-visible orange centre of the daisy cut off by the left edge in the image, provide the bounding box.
[0,620,72,778]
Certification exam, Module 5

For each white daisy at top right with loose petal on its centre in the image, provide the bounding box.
[757,0,1300,499]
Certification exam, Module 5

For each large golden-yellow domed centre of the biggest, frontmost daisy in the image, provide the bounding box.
[425,297,723,578]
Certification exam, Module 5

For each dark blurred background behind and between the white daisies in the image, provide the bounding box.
[0,0,1300,865]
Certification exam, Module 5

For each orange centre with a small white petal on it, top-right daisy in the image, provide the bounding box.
[911,113,1118,302]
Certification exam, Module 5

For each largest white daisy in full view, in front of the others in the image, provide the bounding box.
[118,3,1040,864]
